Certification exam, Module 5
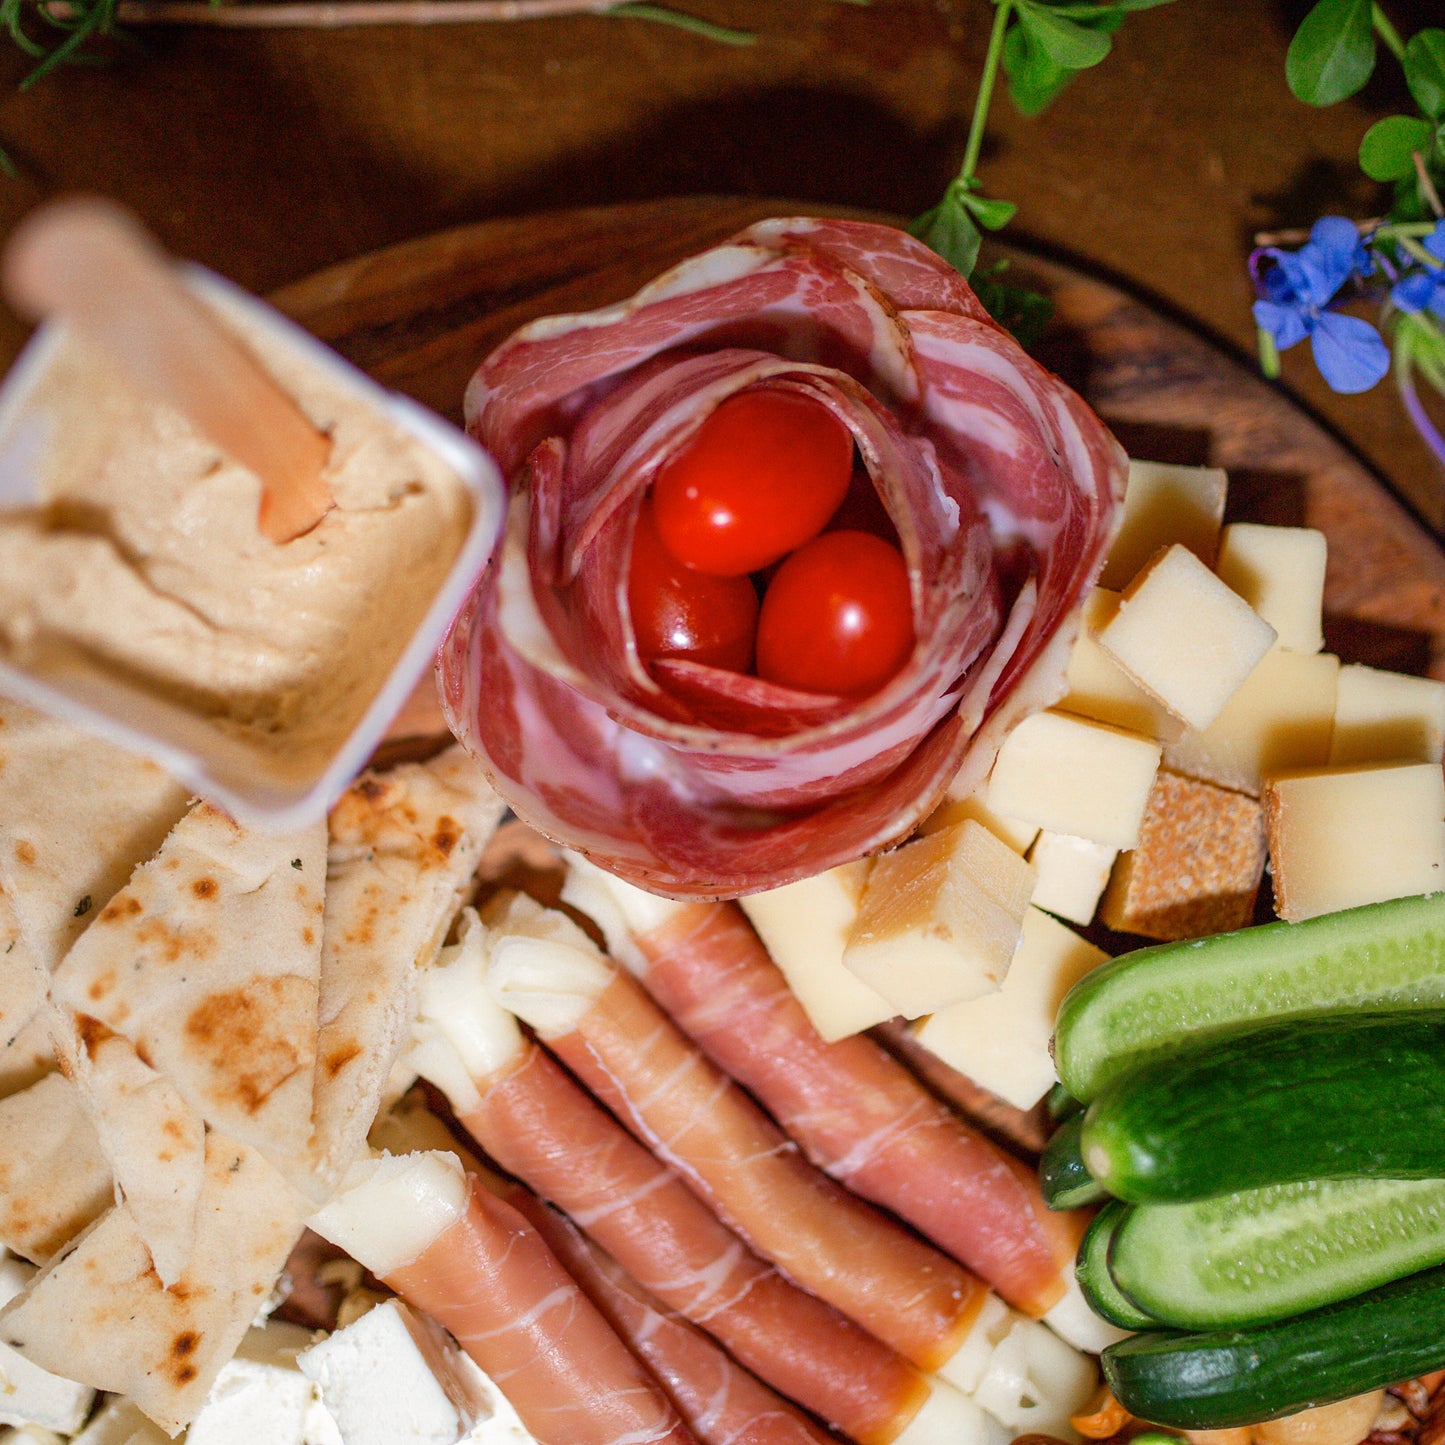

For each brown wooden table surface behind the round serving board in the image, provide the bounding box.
[0,0,1445,533]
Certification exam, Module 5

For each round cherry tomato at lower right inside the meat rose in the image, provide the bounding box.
[757,532,913,696]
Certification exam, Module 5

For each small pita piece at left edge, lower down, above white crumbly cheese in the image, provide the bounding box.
[0,1074,116,1264]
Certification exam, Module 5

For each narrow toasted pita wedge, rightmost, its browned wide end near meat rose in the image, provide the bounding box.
[305,747,506,1199]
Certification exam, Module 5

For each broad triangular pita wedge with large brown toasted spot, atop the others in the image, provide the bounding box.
[51,803,327,1160]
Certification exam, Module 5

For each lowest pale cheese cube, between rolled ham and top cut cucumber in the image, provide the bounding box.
[910,907,1108,1108]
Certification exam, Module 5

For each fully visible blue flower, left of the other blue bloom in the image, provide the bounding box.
[1254,215,1390,392]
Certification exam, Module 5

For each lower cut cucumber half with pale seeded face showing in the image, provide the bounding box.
[1108,1179,1445,1329]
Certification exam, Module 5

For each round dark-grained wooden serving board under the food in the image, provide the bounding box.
[272,197,1445,687]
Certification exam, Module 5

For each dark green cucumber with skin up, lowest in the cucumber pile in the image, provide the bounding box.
[1103,1269,1445,1431]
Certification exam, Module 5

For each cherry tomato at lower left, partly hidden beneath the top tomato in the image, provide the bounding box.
[627,501,757,672]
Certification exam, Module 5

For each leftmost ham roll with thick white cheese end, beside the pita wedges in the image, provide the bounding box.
[312,1153,698,1445]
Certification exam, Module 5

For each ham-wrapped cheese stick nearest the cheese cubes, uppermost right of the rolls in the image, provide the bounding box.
[565,864,1082,1316]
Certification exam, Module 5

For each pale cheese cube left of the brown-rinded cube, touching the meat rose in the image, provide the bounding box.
[987,712,1160,848]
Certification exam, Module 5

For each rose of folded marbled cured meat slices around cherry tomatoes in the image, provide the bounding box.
[441,218,1124,897]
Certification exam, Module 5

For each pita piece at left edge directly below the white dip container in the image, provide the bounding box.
[0,698,188,971]
